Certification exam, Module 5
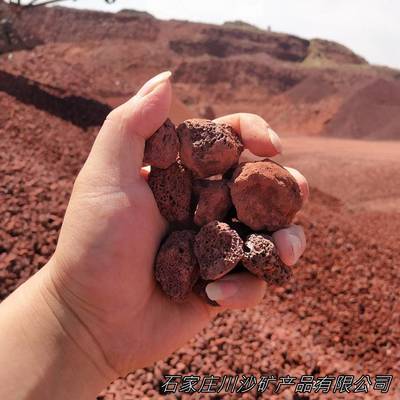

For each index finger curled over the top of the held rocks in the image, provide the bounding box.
[214,113,282,157]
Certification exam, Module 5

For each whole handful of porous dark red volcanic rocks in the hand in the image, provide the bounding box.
[144,119,302,302]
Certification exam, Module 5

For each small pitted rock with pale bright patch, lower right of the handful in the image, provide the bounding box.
[242,234,291,285]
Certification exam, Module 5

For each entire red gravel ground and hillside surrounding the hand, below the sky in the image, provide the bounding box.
[0,3,400,400]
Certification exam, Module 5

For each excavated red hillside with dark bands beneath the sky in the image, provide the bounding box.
[0,3,400,139]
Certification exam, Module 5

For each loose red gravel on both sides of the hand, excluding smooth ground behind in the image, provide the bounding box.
[0,93,400,400]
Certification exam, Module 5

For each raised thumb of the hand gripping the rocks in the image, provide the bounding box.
[81,71,172,186]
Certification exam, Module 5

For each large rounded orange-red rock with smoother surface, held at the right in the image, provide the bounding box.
[230,160,302,231]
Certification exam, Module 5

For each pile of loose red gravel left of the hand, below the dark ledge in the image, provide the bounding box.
[0,92,94,299]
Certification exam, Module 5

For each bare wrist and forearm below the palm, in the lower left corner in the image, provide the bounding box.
[0,261,116,399]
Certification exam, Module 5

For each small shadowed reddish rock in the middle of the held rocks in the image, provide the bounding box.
[193,180,232,226]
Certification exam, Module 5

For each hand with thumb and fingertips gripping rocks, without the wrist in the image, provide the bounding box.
[44,73,308,375]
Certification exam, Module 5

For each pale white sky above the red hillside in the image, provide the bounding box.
[54,0,400,69]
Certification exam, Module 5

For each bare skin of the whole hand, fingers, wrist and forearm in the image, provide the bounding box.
[0,73,308,400]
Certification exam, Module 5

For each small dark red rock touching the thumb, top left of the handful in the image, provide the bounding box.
[143,118,179,169]
